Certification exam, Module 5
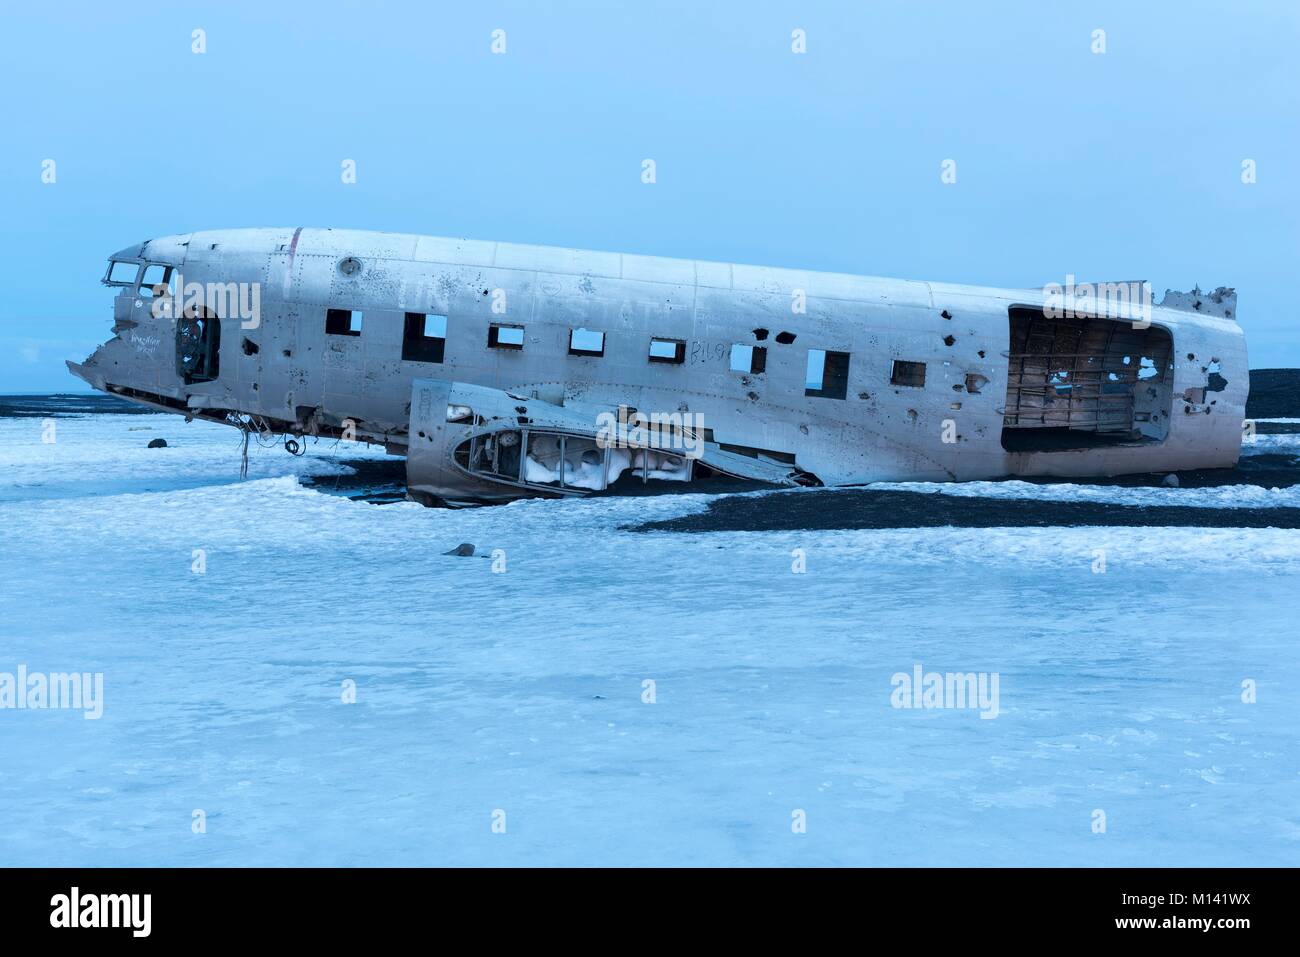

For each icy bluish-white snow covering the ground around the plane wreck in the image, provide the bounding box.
[0,416,1300,865]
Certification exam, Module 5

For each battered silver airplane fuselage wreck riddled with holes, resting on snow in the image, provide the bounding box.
[68,228,1249,505]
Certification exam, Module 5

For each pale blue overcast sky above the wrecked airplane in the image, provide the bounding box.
[0,0,1300,391]
